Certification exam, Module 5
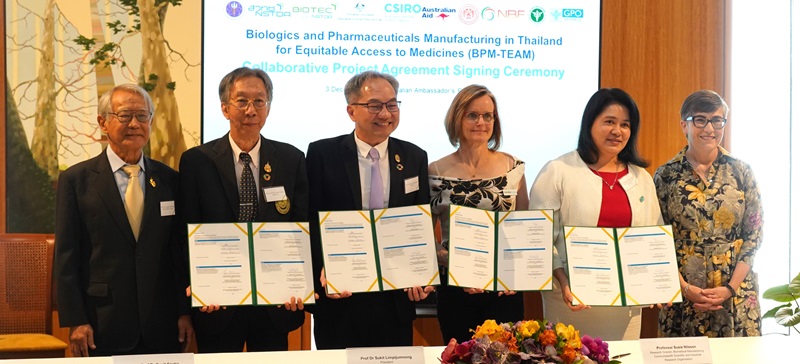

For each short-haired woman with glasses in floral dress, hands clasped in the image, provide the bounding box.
[654,90,762,337]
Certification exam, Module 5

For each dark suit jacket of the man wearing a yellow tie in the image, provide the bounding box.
[53,151,189,352]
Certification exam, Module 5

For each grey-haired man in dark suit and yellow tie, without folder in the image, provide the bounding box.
[53,84,192,356]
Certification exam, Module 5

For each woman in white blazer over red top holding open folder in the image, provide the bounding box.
[530,88,662,340]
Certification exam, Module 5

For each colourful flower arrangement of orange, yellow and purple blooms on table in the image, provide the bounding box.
[439,320,620,364]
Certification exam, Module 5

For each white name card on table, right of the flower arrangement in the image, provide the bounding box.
[639,336,713,364]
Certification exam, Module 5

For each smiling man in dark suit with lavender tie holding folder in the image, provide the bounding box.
[308,71,433,349]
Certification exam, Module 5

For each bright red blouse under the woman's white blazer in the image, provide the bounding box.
[590,167,632,228]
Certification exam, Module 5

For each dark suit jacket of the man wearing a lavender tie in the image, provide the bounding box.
[307,133,430,325]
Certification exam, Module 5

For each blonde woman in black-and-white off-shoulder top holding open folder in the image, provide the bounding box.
[428,85,528,342]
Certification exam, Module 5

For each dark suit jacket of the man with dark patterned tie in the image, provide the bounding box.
[180,134,308,333]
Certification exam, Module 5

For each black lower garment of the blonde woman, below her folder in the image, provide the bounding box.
[436,286,525,345]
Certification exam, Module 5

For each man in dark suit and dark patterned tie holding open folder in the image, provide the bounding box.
[180,67,308,353]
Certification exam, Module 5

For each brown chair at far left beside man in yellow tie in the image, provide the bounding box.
[0,234,67,359]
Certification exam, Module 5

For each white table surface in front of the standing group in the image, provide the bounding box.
[2,335,788,364]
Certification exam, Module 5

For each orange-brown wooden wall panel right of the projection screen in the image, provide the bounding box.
[600,0,728,174]
